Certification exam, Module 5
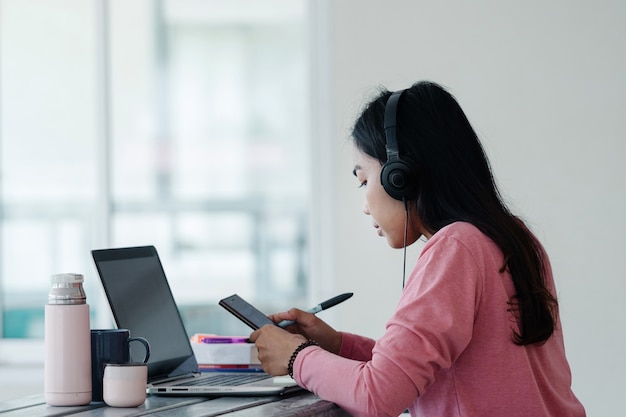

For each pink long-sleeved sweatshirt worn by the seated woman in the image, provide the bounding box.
[294,223,585,417]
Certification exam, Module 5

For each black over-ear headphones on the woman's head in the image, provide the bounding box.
[380,90,416,201]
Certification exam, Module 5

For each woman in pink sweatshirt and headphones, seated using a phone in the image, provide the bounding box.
[250,82,585,417]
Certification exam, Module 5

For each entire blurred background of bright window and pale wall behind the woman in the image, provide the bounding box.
[0,0,626,416]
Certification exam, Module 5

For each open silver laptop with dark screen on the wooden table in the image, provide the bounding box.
[91,246,301,396]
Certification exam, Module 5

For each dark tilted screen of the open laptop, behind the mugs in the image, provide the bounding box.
[92,246,197,380]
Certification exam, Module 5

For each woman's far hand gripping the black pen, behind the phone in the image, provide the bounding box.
[269,308,341,354]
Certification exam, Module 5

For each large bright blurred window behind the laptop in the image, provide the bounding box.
[0,0,310,344]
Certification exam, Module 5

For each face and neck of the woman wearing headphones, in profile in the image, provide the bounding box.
[354,147,423,248]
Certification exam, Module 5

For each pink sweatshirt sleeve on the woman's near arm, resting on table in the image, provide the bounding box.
[294,229,481,417]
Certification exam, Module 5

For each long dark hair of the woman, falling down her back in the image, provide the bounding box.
[352,82,558,345]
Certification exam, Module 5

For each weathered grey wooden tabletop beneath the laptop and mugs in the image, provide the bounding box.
[0,391,349,417]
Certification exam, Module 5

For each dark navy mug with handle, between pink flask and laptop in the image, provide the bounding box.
[91,329,150,401]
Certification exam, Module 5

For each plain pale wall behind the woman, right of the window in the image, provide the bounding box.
[314,0,626,416]
